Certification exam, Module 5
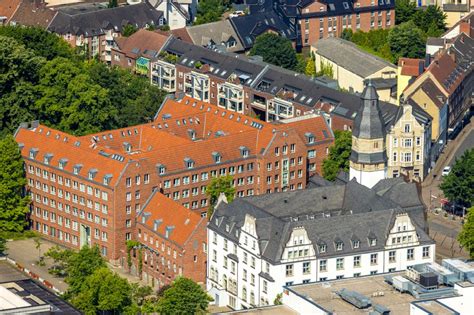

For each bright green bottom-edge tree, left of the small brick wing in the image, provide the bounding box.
[72,267,131,314]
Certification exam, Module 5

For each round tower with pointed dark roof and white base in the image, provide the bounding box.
[349,81,387,188]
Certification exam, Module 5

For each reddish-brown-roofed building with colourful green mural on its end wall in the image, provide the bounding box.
[111,29,171,77]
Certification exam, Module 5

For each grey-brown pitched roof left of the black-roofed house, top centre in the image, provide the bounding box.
[187,20,244,52]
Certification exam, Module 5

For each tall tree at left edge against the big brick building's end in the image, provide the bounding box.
[0,135,30,232]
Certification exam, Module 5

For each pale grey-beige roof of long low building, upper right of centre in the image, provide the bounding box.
[315,37,396,78]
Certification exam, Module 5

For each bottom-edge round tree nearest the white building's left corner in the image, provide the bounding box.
[157,277,212,314]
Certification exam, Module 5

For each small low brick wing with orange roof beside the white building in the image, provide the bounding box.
[134,190,207,287]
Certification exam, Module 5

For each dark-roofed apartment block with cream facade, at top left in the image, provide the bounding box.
[47,2,165,64]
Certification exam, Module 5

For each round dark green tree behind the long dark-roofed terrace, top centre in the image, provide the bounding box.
[250,33,298,70]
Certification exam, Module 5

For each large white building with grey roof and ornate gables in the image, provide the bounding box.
[207,178,435,310]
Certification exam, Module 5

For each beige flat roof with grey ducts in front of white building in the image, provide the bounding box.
[290,272,416,315]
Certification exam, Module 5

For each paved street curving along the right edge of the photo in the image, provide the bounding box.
[422,122,474,259]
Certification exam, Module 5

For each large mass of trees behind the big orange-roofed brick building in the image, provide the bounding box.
[0,26,166,136]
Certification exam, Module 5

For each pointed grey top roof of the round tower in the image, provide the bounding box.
[352,82,385,139]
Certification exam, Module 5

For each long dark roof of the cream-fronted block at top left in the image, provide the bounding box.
[48,2,163,37]
